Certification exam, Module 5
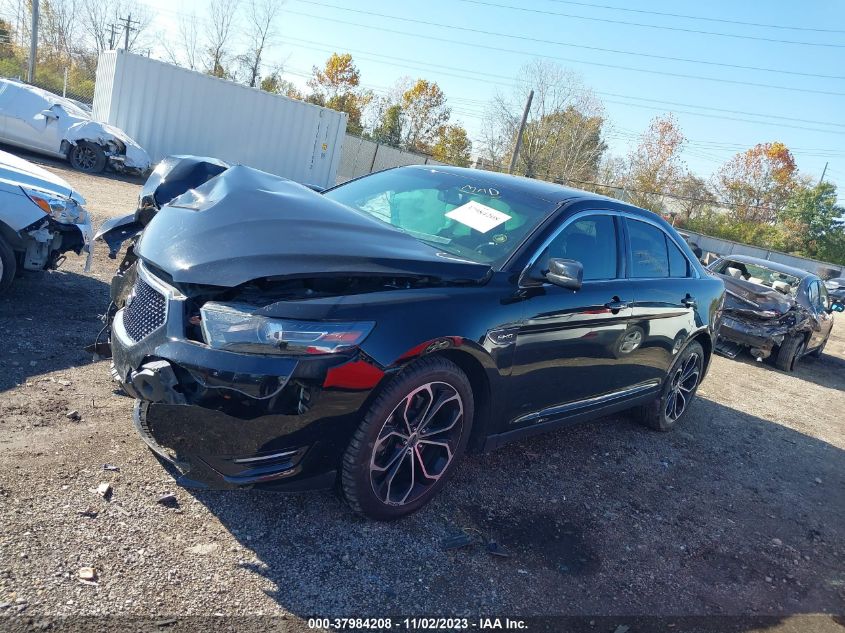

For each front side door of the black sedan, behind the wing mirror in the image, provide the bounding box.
[509,212,633,427]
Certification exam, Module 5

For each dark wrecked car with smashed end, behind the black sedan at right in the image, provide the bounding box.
[709,255,845,371]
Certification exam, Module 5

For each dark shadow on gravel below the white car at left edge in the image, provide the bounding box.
[0,270,109,392]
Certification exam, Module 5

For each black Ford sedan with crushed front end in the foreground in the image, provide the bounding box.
[98,158,724,519]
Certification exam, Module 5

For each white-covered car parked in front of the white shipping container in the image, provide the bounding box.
[0,79,150,174]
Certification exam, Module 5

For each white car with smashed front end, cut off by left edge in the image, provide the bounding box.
[0,151,92,294]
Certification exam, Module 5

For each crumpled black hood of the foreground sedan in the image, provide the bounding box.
[137,165,490,287]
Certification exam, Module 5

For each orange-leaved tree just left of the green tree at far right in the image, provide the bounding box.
[714,142,796,223]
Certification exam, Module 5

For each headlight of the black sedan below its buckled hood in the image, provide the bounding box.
[200,301,375,354]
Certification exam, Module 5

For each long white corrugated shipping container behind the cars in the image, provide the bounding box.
[93,50,347,187]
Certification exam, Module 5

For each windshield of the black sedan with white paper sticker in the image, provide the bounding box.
[325,168,558,267]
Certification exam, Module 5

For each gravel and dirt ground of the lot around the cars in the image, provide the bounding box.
[0,156,845,631]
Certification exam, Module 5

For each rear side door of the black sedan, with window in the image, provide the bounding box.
[625,217,697,384]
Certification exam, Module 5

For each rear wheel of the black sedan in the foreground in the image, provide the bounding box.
[634,341,704,431]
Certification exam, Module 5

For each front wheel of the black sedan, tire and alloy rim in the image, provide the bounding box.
[341,357,474,521]
